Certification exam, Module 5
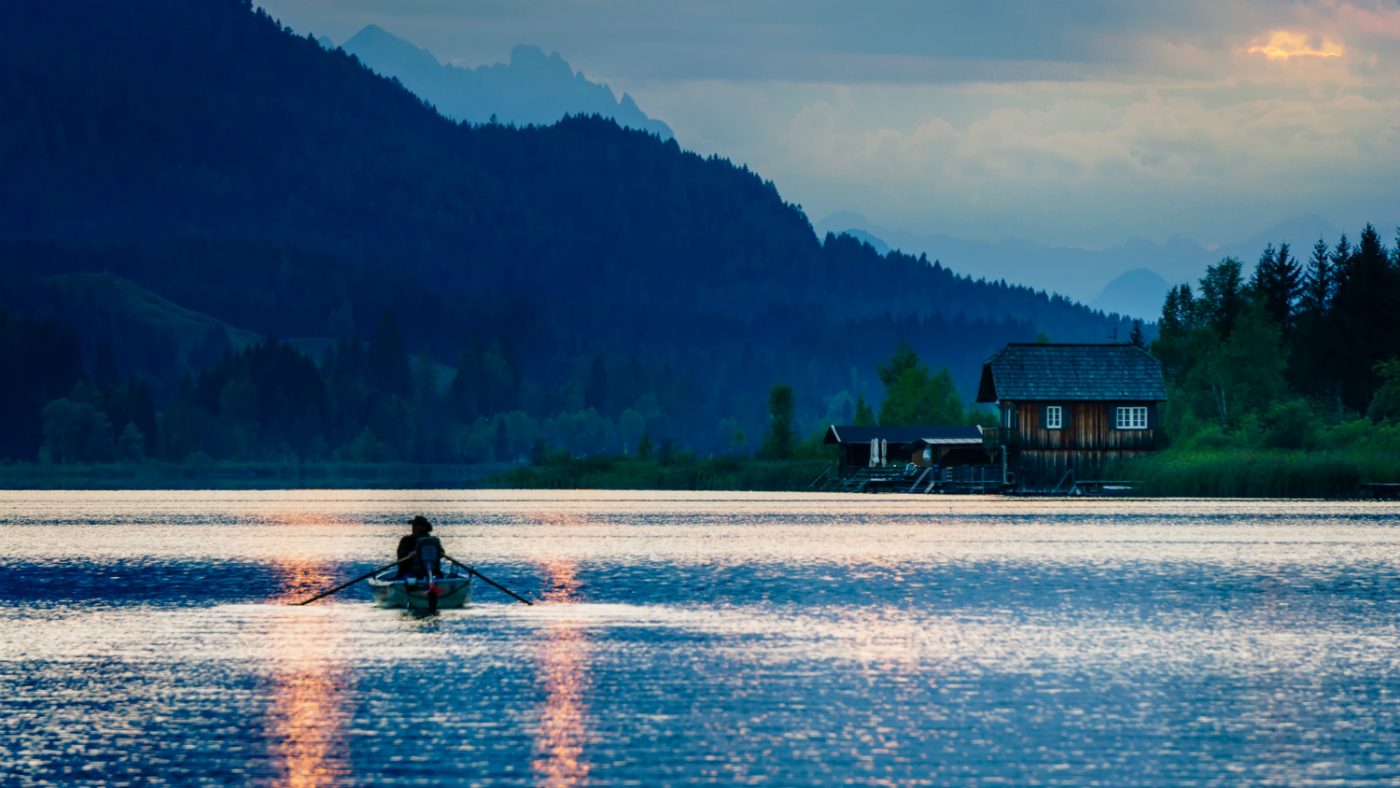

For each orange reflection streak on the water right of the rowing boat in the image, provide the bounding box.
[532,561,588,787]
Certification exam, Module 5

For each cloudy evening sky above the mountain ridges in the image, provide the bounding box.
[259,0,1400,248]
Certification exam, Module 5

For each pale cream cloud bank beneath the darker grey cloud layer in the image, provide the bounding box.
[638,75,1400,246]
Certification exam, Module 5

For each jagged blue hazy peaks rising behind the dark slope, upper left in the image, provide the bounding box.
[333,25,672,140]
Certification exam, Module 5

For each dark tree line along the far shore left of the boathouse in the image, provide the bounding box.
[0,293,977,465]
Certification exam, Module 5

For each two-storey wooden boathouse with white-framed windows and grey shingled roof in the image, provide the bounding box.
[977,343,1166,491]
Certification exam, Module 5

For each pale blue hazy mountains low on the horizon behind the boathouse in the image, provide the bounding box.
[816,211,1360,321]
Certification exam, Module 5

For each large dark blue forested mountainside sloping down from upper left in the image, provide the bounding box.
[0,0,1128,459]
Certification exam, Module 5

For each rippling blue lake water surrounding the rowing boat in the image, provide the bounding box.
[0,491,1400,785]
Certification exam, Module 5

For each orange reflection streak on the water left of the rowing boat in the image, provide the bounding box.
[267,512,350,788]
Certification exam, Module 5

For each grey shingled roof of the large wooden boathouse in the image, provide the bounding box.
[977,343,1166,402]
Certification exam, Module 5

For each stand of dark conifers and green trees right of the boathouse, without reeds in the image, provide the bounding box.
[1152,224,1400,448]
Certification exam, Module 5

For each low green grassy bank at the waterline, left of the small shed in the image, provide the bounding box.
[489,456,832,490]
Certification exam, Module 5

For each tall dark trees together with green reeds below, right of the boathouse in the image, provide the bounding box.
[1130,224,1400,495]
